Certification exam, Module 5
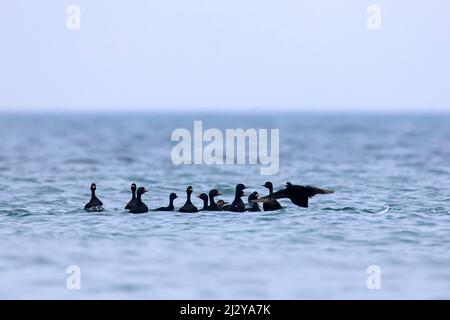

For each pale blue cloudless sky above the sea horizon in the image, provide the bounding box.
[0,0,450,112]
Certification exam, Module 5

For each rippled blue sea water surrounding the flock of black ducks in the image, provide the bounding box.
[0,113,450,299]
